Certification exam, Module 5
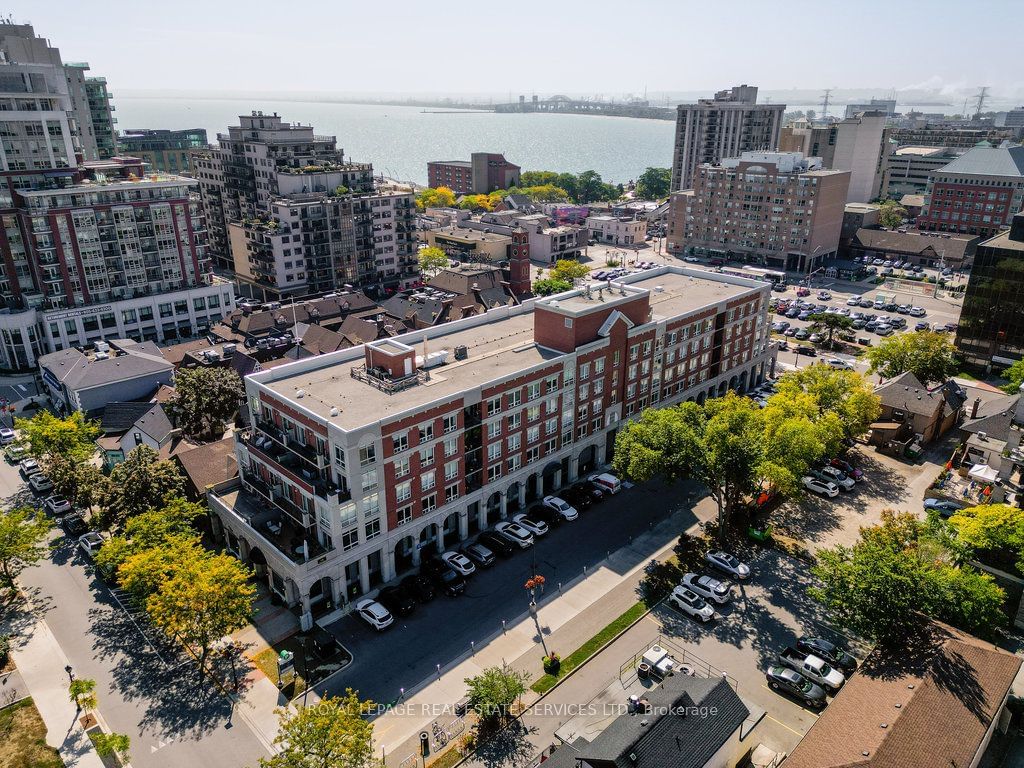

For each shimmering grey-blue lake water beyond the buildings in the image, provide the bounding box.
[115,95,675,184]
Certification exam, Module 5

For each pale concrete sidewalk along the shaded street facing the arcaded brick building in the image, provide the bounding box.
[374,499,716,768]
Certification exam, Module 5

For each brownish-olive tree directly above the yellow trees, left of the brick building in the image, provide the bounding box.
[100,445,185,530]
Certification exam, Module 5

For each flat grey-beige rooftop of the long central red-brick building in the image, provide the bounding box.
[255,267,759,430]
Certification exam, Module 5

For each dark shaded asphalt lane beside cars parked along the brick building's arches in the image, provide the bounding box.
[316,482,697,702]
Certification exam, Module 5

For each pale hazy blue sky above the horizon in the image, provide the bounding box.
[7,0,1024,97]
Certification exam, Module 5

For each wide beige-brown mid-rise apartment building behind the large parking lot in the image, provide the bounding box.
[668,152,850,272]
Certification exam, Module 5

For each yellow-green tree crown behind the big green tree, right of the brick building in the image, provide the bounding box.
[772,366,882,437]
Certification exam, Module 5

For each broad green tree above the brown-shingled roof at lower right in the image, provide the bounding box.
[808,518,1005,642]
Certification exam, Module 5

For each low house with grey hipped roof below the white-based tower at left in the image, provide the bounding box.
[39,339,174,414]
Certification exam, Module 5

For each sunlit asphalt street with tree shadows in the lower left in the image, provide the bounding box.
[0,460,267,768]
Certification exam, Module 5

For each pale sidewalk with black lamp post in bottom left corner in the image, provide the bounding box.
[3,605,104,768]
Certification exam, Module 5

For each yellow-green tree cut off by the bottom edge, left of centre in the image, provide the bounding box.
[259,688,377,768]
